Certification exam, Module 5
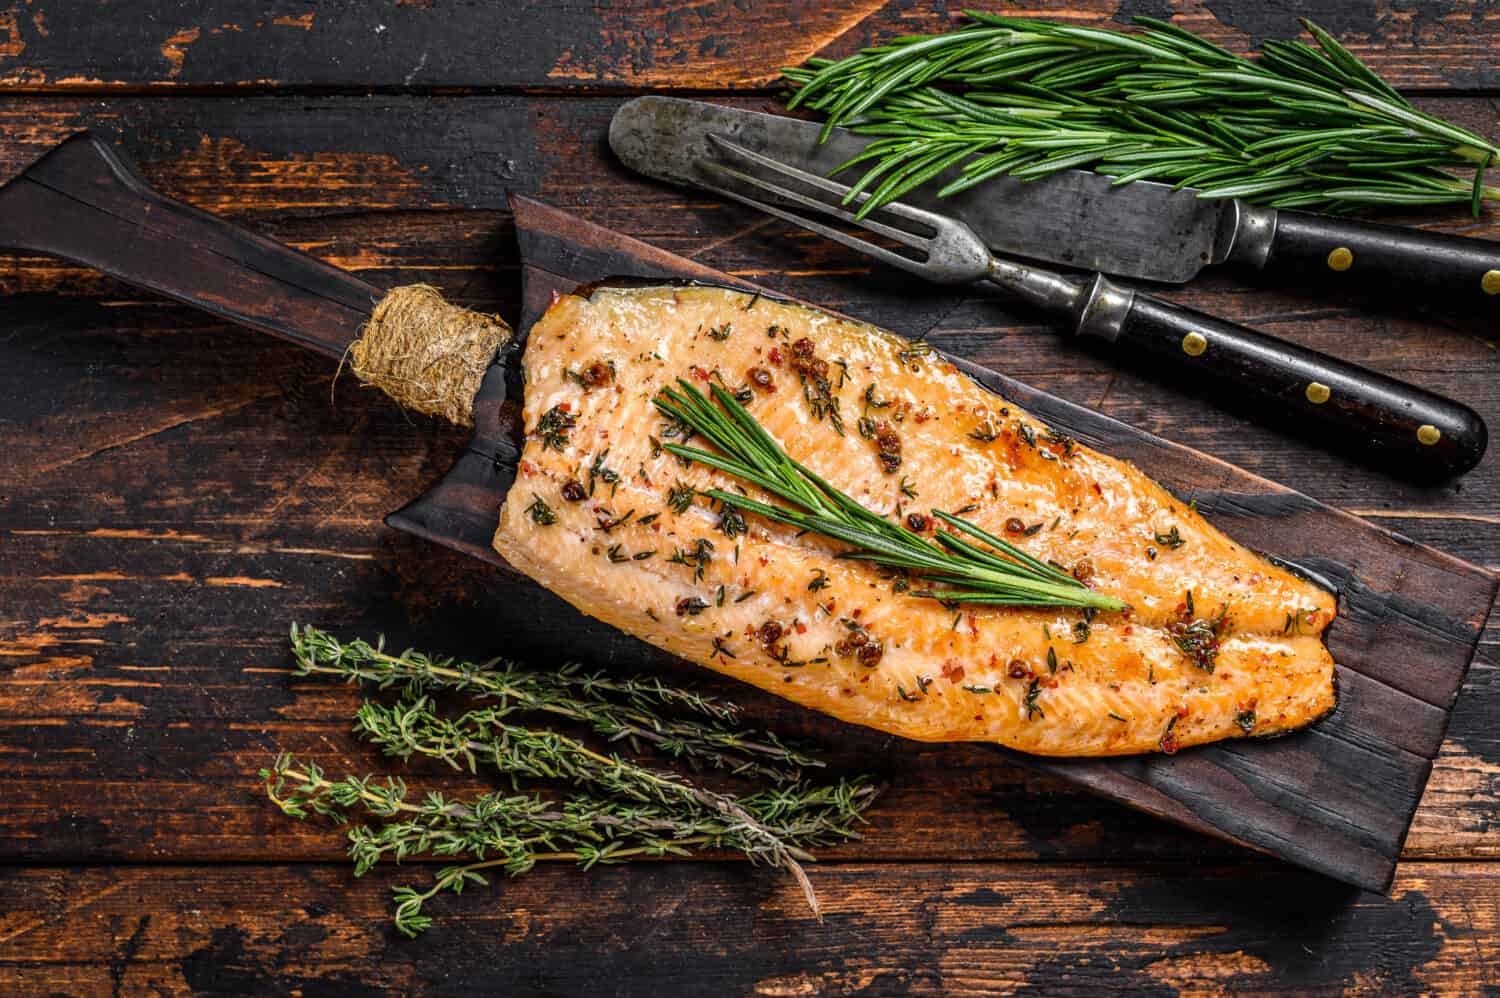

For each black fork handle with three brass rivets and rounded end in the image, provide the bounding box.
[1079,278,1488,482]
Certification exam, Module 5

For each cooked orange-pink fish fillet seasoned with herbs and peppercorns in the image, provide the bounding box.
[494,287,1335,756]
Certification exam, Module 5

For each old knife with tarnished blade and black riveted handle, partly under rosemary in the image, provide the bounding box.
[611,96,1500,314]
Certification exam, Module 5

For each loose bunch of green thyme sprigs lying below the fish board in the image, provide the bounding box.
[270,627,875,936]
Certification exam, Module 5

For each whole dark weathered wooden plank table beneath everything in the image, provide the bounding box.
[0,0,1500,995]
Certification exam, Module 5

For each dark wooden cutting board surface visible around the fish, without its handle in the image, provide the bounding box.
[392,190,1497,891]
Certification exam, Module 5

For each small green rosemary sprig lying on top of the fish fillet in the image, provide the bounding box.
[654,378,1125,609]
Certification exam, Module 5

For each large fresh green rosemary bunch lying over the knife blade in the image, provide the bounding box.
[783,11,1500,216]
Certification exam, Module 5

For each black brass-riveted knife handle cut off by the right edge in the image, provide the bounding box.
[1262,210,1500,318]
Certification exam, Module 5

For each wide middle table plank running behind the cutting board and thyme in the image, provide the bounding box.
[0,98,1500,861]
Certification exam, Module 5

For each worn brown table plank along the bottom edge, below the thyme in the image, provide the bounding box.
[0,863,1500,996]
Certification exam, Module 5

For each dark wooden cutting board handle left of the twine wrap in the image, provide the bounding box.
[0,132,384,357]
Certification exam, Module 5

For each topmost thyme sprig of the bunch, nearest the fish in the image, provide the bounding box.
[291,624,822,783]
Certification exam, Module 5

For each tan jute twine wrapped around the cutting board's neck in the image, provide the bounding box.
[348,284,510,426]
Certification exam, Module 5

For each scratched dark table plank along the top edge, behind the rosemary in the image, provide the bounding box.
[0,0,1500,90]
